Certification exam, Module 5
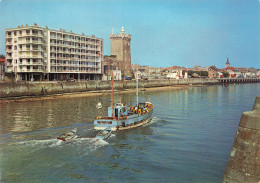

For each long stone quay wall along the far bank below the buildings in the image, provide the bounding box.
[0,78,217,98]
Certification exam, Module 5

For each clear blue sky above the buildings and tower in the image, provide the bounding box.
[0,0,260,69]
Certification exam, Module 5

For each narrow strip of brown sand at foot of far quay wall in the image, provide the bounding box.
[0,84,199,104]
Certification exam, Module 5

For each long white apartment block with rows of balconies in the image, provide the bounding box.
[5,24,103,81]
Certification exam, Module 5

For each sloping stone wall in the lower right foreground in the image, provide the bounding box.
[223,96,260,183]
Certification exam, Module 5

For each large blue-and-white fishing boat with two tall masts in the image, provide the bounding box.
[94,75,154,131]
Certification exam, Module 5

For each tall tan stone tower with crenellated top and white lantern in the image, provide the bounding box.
[109,27,132,76]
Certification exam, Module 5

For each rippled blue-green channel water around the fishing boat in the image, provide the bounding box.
[0,83,260,183]
